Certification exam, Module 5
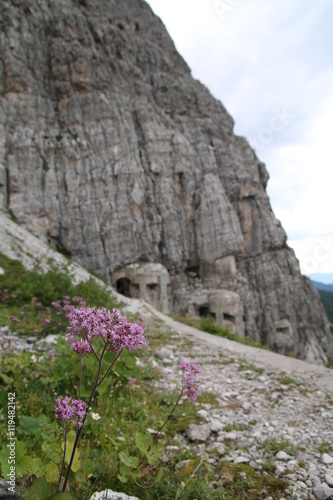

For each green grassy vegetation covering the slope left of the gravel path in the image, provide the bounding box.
[0,255,284,500]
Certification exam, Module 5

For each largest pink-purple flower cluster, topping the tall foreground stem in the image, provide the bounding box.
[66,307,147,356]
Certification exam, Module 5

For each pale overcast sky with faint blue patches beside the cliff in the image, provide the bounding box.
[148,0,333,281]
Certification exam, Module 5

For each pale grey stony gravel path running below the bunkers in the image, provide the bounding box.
[124,302,333,500]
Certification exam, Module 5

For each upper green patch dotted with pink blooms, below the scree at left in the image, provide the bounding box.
[0,253,118,338]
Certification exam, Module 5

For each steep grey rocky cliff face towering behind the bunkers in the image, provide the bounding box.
[0,0,333,362]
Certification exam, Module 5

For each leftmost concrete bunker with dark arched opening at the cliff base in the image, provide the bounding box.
[111,263,171,313]
